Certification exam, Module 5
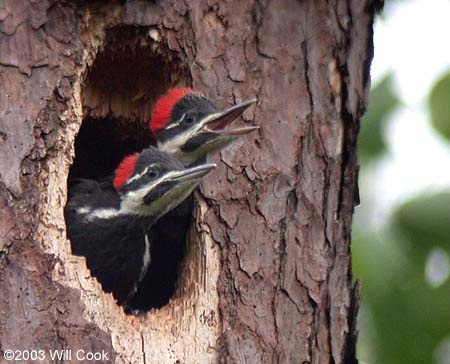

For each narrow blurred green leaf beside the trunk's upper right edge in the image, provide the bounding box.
[358,73,400,163]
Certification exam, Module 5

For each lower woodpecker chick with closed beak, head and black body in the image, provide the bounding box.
[64,147,215,304]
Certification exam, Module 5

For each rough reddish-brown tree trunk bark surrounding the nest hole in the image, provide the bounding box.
[0,0,373,364]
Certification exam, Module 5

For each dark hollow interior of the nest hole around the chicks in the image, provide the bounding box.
[68,28,192,313]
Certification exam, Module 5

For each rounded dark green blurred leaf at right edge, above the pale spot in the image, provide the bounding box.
[393,191,450,250]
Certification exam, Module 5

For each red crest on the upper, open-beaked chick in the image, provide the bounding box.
[149,87,197,133]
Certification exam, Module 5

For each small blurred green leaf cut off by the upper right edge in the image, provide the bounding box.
[428,71,450,140]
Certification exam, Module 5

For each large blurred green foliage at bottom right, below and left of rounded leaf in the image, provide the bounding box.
[353,224,450,364]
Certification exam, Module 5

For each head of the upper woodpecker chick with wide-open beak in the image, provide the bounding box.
[149,88,258,165]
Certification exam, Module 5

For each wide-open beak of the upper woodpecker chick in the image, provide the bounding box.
[202,99,259,136]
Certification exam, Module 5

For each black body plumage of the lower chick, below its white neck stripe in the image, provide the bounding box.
[65,196,149,305]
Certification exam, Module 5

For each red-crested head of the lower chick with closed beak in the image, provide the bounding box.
[113,147,215,218]
